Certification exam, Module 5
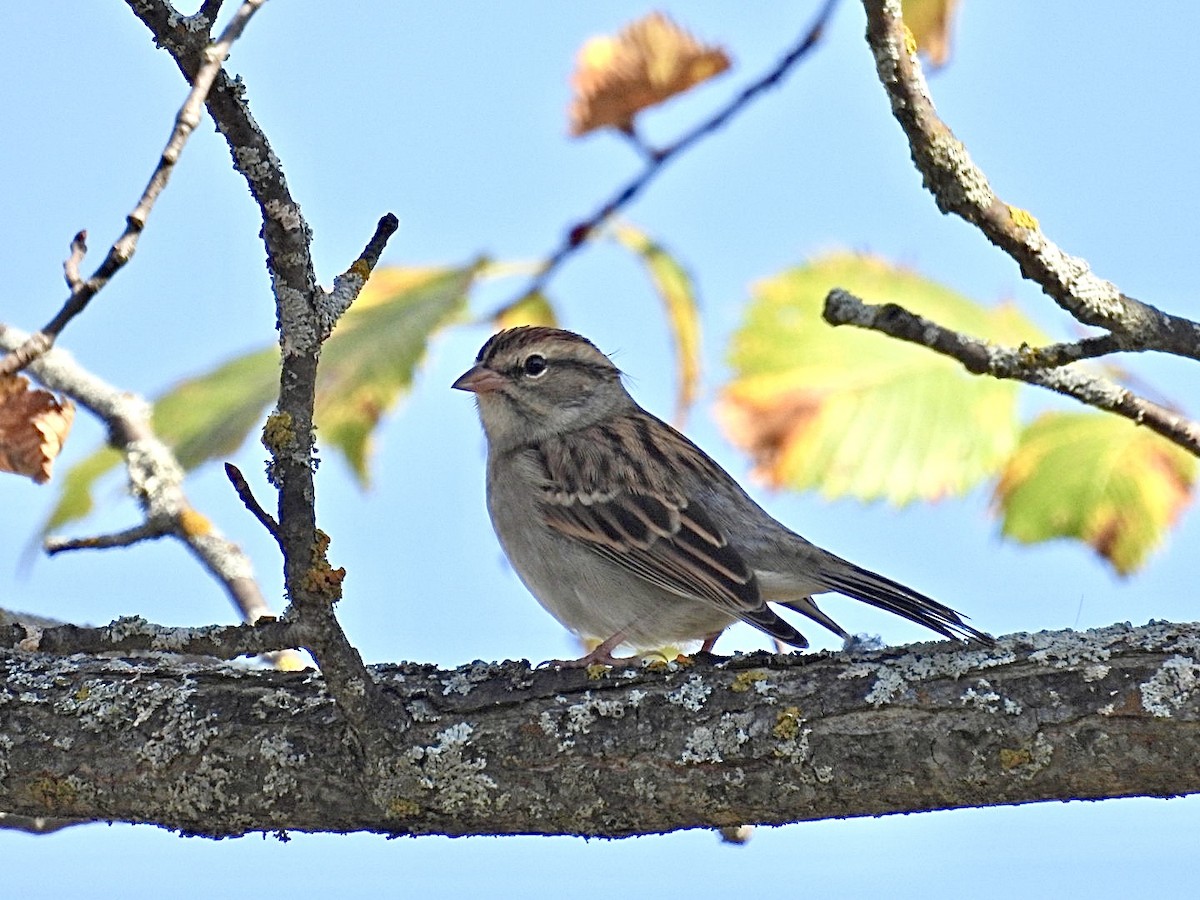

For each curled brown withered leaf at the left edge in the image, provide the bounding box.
[0,376,74,485]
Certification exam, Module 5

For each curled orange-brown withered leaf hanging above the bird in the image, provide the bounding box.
[570,12,730,137]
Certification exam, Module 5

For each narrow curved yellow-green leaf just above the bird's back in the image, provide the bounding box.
[613,224,700,424]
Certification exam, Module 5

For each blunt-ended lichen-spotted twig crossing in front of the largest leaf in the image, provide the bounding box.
[824,288,1200,456]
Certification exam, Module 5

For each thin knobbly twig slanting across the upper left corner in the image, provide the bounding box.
[0,0,266,376]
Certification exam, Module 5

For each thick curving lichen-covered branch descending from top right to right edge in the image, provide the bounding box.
[863,0,1200,360]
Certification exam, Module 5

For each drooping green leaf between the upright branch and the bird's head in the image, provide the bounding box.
[316,264,479,485]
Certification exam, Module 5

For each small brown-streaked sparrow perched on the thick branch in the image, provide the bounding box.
[454,326,991,666]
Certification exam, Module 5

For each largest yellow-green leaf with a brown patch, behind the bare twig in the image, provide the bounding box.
[719,253,1043,504]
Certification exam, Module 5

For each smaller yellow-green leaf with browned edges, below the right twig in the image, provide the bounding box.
[996,413,1196,575]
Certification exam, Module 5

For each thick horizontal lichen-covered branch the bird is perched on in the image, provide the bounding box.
[0,623,1200,836]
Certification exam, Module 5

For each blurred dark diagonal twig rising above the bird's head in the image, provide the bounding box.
[492,0,838,318]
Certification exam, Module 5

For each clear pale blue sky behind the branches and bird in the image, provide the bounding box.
[0,0,1200,896]
